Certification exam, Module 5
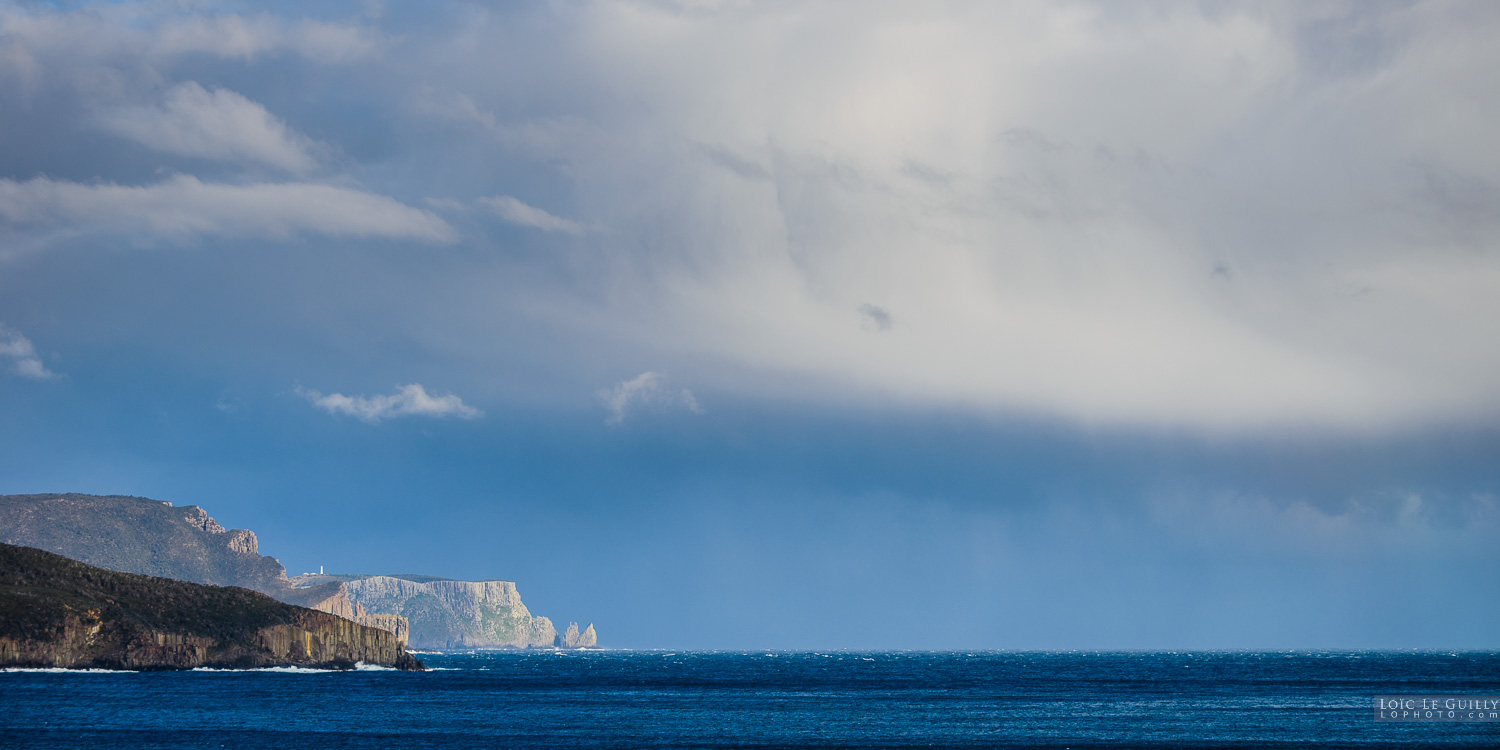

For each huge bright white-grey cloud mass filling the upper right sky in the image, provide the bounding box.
[408,3,1500,431]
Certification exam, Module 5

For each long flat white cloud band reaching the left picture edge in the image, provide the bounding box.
[0,176,458,242]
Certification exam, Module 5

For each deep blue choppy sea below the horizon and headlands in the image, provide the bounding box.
[0,651,1500,750]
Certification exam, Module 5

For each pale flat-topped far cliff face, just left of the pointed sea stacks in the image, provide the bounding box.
[291,576,558,648]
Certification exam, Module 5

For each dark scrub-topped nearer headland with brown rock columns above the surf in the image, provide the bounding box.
[0,545,423,669]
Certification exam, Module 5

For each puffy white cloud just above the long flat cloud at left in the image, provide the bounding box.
[99,81,317,173]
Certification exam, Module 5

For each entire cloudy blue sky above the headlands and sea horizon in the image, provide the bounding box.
[0,0,1500,650]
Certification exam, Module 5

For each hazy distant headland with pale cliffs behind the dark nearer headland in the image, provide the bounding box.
[0,494,599,648]
